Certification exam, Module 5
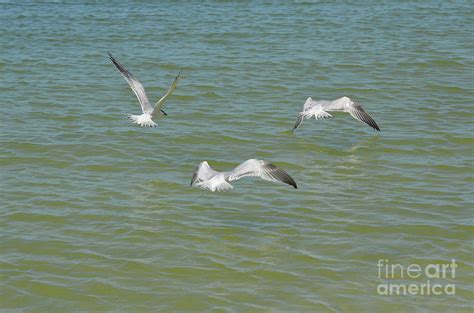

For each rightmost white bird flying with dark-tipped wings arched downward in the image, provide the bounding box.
[291,97,380,131]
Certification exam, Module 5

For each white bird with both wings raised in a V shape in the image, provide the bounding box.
[107,52,181,127]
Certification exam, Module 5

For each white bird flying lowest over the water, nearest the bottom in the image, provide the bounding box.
[190,159,298,192]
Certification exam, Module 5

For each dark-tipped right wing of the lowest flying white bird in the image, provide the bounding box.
[227,159,297,188]
